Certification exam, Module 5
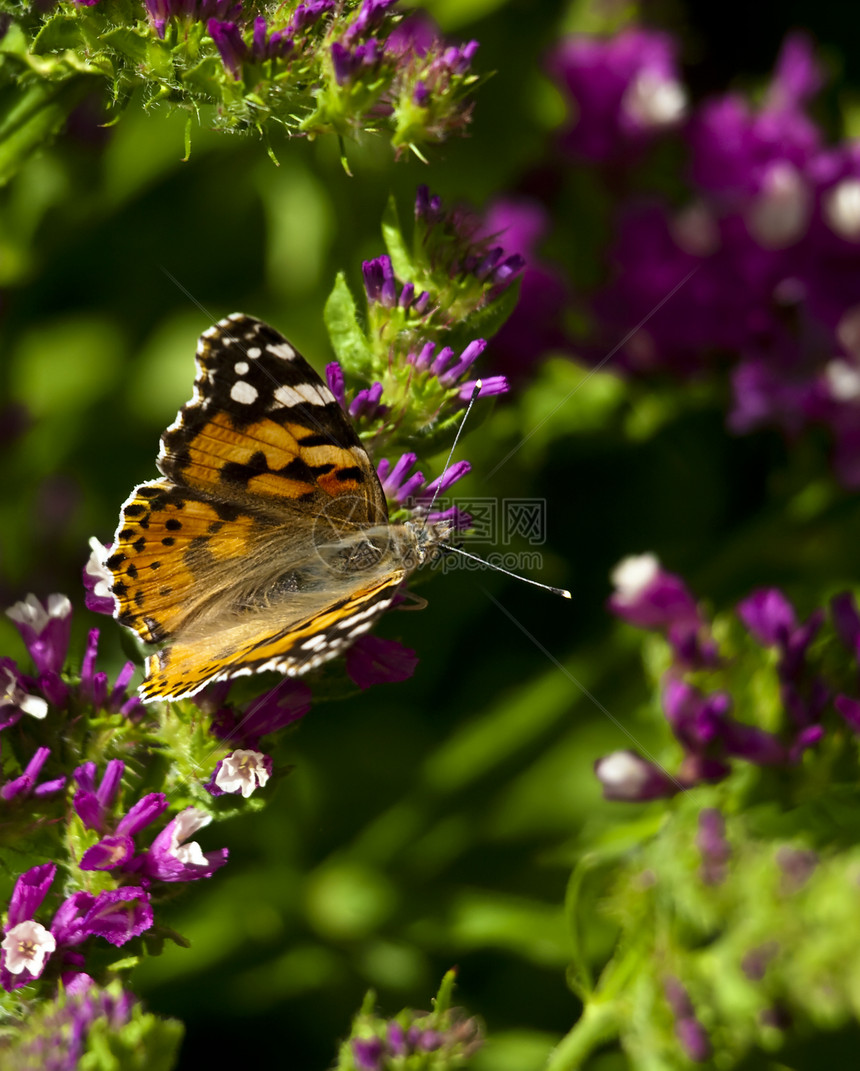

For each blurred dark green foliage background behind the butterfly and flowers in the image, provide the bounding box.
[0,0,860,1071]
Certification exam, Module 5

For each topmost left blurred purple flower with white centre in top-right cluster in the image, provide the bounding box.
[549,28,687,163]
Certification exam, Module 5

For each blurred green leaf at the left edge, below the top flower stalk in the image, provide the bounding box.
[0,75,94,185]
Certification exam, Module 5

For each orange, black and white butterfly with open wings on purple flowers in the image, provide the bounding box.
[106,313,452,700]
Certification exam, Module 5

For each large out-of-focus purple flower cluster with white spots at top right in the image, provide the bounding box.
[488,28,860,487]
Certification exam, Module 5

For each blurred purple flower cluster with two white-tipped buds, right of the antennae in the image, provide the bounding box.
[595,555,860,801]
